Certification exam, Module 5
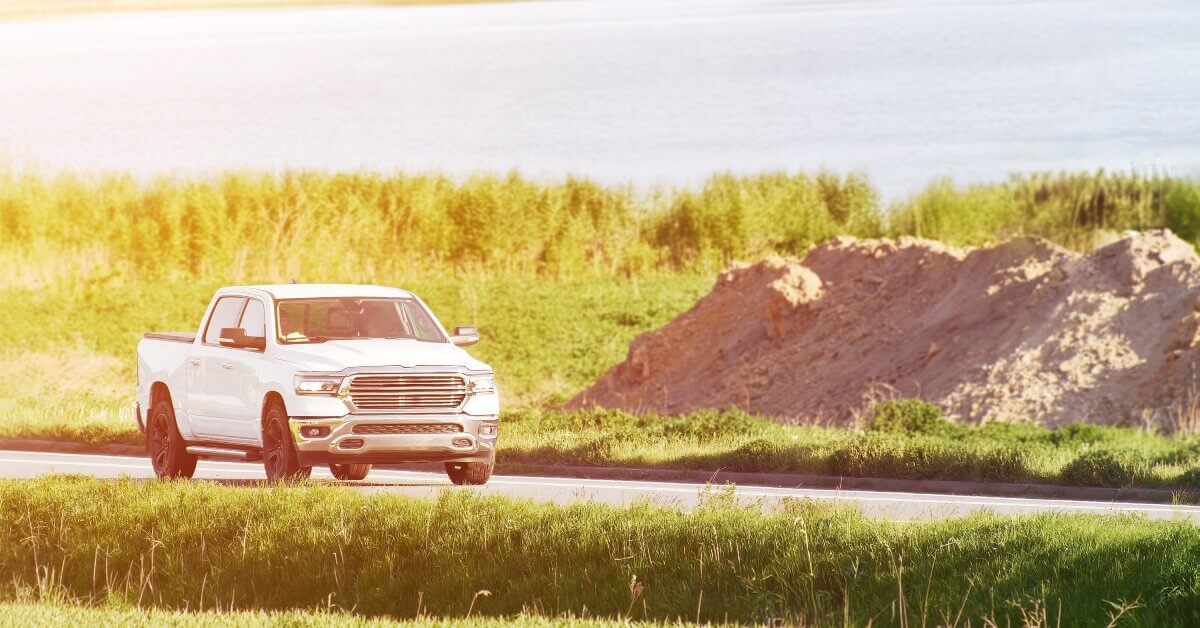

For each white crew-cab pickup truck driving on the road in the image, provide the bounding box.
[133,283,499,484]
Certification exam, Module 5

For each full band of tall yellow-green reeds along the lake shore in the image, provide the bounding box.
[0,166,1200,286]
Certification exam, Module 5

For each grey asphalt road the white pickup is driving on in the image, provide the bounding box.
[0,450,1200,522]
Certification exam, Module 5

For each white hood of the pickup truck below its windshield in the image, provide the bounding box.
[275,339,491,371]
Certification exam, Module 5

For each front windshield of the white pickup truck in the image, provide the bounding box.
[276,299,446,345]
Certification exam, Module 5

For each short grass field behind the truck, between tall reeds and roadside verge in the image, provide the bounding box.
[0,275,713,413]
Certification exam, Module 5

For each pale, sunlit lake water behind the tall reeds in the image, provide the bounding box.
[0,0,1200,197]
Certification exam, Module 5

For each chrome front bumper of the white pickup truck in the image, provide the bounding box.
[290,414,499,466]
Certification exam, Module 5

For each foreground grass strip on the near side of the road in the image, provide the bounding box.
[0,477,1200,626]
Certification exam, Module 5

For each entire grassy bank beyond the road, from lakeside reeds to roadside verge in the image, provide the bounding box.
[0,169,1200,486]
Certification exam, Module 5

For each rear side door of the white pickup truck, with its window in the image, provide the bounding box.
[187,297,246,441]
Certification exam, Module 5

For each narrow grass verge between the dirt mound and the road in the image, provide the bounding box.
[499,400,1200,490]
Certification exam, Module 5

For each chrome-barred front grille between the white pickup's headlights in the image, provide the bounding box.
[347,373,467,412]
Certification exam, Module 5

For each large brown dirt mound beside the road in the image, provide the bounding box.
[571,231,1200,425]
